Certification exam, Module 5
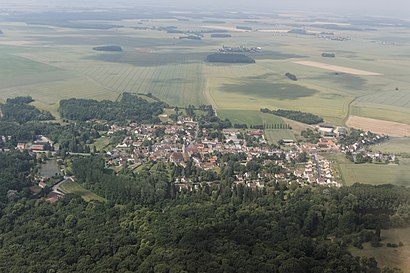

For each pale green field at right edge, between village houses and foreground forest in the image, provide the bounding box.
[339,159,410,186]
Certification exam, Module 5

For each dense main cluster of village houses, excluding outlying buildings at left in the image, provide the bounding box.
[107,120,339,189]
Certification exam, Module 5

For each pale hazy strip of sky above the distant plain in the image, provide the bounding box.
[0,0,410,19]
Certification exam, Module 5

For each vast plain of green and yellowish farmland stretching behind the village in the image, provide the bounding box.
[0,11,410,133]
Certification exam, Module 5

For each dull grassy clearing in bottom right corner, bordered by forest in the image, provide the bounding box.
[349,225,410,273]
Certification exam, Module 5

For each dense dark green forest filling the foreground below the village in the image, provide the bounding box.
[0,152,410,273]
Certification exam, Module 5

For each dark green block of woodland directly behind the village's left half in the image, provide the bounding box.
[59,93,166,123]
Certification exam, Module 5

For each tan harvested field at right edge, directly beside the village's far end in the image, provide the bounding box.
[346,116,410,137]
